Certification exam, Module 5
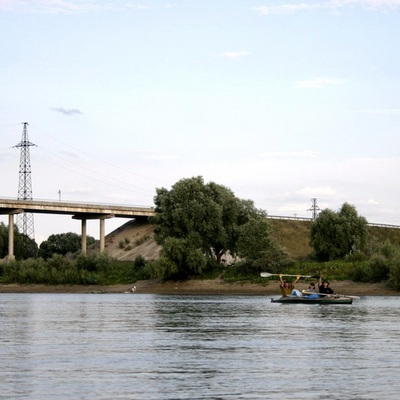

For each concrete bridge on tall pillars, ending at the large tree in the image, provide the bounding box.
[0,198,154,259]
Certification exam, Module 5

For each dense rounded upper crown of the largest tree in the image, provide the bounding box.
[151,177,241,263]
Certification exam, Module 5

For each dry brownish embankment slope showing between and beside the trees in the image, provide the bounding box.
[100,219,400,261]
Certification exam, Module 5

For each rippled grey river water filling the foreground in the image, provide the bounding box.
[0,293,400,400]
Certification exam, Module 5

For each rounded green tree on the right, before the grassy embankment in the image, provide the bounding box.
[310,203,368,261]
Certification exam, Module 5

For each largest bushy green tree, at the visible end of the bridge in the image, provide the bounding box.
[150,176,288,278]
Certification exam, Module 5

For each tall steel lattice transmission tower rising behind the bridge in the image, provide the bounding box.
[14,122,36,240]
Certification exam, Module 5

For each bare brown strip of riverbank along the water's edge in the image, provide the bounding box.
[0,279,400,296]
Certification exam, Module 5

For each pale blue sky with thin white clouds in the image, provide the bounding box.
[0,0,400,243]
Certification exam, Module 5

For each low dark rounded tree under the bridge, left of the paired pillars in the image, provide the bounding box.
[39,232,95,259]
